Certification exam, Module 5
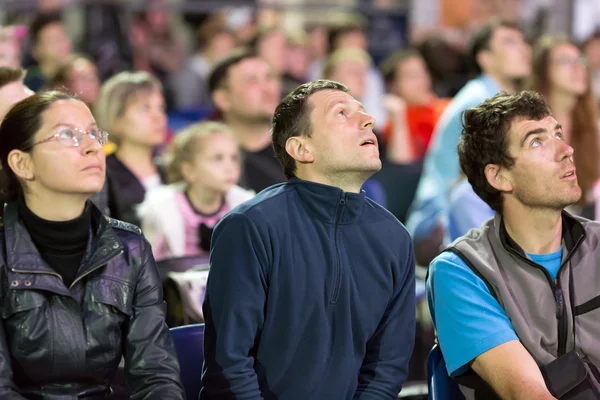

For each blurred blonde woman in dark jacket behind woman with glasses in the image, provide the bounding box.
[95,72,167,225]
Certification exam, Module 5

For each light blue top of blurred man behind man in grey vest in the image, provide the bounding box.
[406,75,500,241]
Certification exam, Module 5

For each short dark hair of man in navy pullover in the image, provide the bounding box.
[271,79,348,179]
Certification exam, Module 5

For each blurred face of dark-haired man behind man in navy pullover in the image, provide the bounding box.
[213,58,281,123]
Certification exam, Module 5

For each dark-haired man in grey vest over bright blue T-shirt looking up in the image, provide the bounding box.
[427,92,600,399]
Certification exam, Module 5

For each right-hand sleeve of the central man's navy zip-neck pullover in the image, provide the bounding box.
[354,234,416,400]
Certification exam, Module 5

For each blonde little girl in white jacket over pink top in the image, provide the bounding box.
[138,122,254,259]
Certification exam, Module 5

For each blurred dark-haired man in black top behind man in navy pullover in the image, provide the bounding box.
[208,50,284,192]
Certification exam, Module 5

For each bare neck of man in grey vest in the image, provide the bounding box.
[503,200,562,254]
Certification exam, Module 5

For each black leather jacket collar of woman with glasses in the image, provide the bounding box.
[4,201,123,294]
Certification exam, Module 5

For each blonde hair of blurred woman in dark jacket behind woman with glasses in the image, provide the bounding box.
[94,71,162,140]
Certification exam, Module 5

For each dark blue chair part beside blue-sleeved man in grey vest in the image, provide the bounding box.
[427,344,465,400]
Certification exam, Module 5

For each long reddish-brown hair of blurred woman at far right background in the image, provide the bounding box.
[527,36,600,205]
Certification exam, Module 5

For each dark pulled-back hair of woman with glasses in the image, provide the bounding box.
[0,90,79,202]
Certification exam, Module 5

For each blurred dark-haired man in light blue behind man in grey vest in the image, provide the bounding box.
[406,20,531,265]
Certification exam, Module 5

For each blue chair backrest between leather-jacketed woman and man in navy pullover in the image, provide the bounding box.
[171,324,204,399]
